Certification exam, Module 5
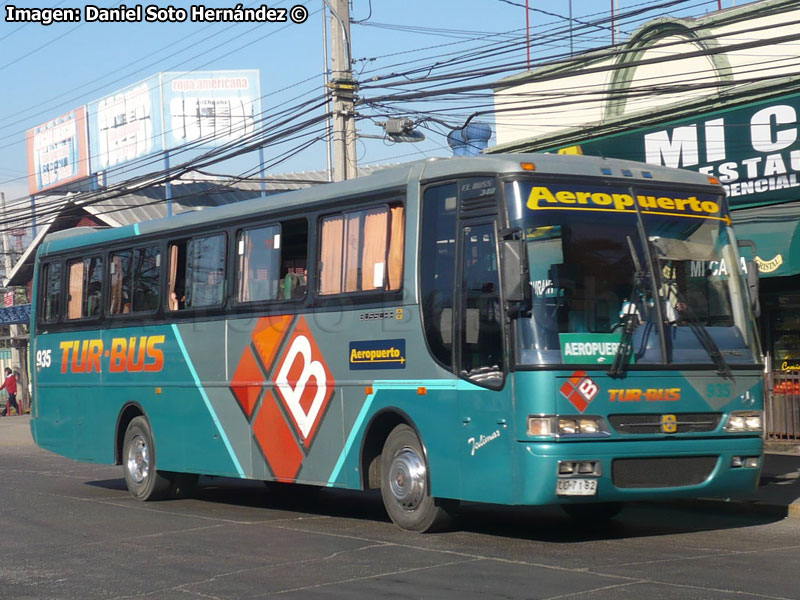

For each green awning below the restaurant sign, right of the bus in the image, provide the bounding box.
[732,202,800,277]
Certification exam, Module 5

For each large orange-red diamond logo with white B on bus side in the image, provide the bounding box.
[231,316,335,481]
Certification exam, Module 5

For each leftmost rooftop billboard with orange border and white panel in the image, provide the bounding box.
[27,106,89,194]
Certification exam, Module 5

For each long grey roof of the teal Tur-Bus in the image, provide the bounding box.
[40,153,720,254]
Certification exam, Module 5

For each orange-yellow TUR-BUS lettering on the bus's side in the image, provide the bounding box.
[60,335,165,373]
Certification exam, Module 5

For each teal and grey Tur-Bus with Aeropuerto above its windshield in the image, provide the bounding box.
[31,154,763,531]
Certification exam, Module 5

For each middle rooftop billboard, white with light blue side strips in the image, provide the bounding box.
[89,75,164,173]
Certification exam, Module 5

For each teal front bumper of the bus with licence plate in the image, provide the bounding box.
[515,437,763,505]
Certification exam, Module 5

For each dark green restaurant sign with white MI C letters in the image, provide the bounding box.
[562,94,800,208]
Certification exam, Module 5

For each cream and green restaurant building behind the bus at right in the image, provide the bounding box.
[489,0,800,440]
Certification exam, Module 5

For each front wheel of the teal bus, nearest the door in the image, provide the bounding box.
[381,425,450,533]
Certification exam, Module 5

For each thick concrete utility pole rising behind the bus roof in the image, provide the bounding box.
[327,0,357,181]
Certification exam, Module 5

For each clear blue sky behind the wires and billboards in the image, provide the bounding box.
[0,0,745,209]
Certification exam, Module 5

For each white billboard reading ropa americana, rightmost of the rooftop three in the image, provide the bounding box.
[162,70,261,149]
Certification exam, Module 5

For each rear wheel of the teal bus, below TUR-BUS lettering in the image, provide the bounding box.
[122,417,172,501]
